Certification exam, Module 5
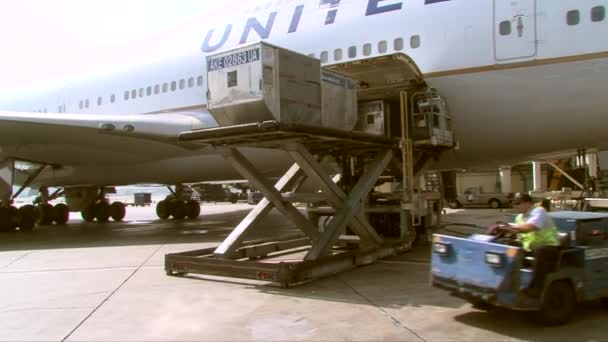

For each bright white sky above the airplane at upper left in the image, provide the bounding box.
[0,0,228,91]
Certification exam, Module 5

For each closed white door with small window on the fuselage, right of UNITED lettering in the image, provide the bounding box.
[494,0,536,61]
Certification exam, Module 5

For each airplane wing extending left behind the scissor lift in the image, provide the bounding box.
[0,111,217,165]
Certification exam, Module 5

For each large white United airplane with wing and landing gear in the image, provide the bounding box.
[0,0,608,228]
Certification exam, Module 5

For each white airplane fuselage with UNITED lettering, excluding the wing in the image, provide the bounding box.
[0,0,608,185]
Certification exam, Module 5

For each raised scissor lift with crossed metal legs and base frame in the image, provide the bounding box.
[165,121,411,287]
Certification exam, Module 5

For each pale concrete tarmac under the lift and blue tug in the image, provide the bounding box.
[0,204,608,341]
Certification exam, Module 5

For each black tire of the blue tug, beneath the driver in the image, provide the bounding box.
[539,281,576,325]
